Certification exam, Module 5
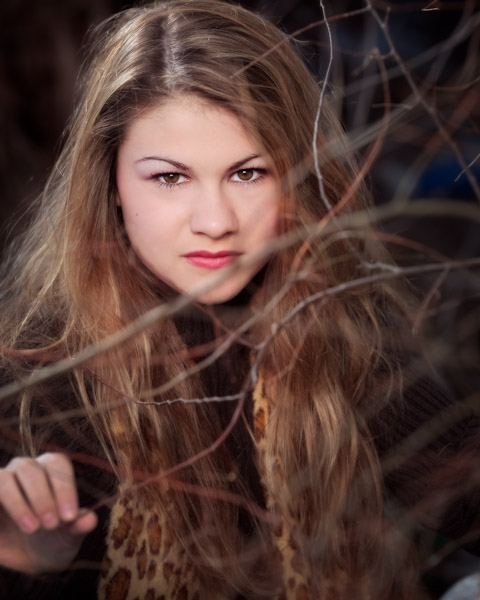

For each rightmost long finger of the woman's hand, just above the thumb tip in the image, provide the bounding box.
[37,453,78,522]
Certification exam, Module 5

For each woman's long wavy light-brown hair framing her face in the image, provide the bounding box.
[0,0,416,598]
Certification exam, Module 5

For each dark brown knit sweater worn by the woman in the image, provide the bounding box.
[0,360,480,600]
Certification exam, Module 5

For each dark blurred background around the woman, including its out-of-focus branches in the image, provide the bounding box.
[0,0,480,597]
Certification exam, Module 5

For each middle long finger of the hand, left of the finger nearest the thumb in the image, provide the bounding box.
[7,458,59,529]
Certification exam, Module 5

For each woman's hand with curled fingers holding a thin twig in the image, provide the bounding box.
[0,453,97,574]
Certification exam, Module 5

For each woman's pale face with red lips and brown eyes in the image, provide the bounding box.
[117,96,281,304]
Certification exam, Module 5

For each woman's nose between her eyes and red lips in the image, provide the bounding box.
[190,186,238,239]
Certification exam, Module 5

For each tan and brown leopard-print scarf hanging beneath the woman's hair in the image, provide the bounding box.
[98,380,368,600]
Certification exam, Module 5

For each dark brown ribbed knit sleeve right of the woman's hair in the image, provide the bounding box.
[372,360,480,553]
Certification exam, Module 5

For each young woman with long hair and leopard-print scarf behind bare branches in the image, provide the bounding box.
[0,0,478,600]
